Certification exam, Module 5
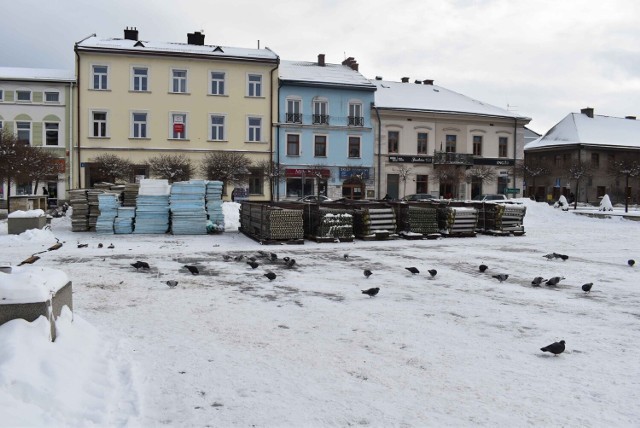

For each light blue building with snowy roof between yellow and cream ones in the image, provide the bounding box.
[273,54,376,200]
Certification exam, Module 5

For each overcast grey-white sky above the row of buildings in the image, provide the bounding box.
[0,0,640,133]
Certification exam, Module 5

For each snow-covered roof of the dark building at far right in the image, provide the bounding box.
[524,113,640,150]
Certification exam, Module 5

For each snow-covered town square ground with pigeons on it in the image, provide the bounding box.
[0,199,640,427]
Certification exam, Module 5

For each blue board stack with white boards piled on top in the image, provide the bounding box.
[133,179,171,234]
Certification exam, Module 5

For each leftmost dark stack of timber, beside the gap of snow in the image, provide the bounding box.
[240,201,304,243]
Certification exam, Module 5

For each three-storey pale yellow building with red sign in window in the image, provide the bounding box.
[74,29,279,199]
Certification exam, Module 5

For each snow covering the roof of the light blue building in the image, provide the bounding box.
[278,60,375,91]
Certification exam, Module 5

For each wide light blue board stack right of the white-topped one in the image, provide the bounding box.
[169,180,207,235]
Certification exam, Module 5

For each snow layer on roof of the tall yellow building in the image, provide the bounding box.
[77,36,278,61]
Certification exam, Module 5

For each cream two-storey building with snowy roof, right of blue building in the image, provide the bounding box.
[372,78,530,199]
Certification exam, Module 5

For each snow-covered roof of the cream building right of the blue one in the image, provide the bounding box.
[371,80,529,120]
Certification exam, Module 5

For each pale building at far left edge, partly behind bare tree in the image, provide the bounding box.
[0,67,75,205]
